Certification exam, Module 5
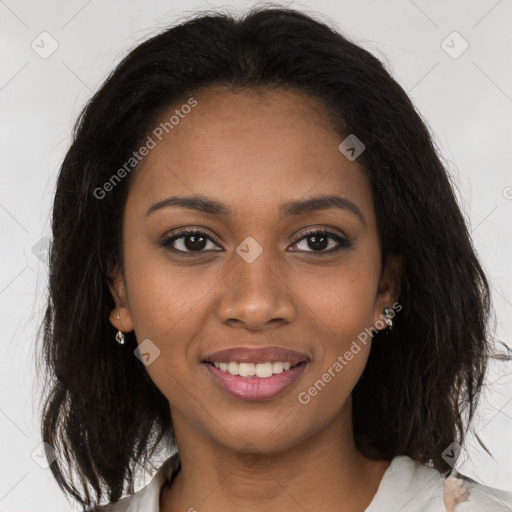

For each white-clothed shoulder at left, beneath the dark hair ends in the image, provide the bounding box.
[95,454,180,512]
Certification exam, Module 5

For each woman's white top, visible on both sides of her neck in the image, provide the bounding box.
[100,455,512,512]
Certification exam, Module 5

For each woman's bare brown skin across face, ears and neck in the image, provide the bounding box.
[110,87,400,512]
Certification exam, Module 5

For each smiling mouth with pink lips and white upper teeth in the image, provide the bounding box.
[202,347,310,401]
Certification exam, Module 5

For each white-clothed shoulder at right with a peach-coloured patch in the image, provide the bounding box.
[366,455,512,512]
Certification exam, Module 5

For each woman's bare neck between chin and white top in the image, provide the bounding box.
[160,404,390,512]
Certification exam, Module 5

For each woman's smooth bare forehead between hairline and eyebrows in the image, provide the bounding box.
[125,88,373,222]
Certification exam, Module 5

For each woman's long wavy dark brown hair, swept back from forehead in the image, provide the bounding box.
[40,5,508,510]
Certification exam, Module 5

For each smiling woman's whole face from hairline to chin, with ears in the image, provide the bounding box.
[111,88,397,451]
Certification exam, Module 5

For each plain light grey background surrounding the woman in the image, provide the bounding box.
[0,0,512,512]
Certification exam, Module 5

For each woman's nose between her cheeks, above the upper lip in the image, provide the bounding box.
[217,246,298,331]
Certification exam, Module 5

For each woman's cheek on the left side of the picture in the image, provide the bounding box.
[121,251,211,404]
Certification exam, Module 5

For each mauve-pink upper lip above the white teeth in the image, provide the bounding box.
[203,346,309,364]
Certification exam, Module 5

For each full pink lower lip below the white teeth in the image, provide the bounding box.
[203,362,306,400]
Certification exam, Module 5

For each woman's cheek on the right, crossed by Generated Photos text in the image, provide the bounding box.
[292,251,379,396]
